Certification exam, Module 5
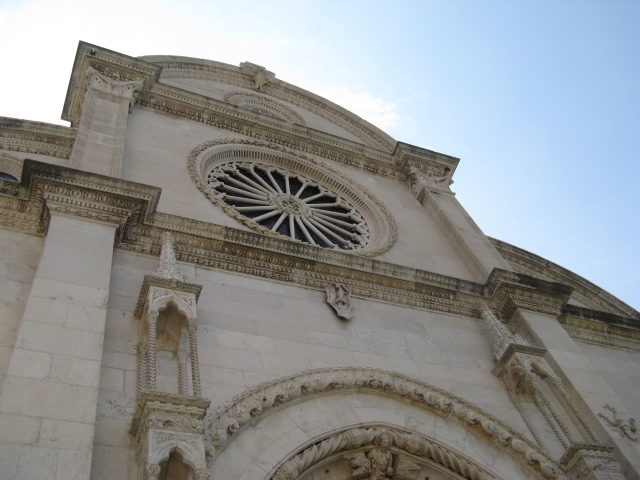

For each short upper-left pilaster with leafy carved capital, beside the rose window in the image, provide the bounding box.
[69,67,143,177]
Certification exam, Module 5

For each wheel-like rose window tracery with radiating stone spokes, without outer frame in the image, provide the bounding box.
[207,162,370,250]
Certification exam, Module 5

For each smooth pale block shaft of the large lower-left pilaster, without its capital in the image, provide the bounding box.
[0,212,117,480]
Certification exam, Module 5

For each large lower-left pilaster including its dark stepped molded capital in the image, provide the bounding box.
[0,161,158,480]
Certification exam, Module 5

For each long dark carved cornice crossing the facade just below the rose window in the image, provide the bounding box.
[0,160,635,341]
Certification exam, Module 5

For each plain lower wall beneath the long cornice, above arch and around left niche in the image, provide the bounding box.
[92,250,528,480]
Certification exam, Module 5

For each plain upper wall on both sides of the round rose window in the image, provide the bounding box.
[123,109,480,282]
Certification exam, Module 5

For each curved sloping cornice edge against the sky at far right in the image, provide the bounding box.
[489,238,640,319]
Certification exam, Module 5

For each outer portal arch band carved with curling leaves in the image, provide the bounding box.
[205,367,564,479]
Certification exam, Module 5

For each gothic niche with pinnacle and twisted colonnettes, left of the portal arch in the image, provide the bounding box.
[131,232,210,480]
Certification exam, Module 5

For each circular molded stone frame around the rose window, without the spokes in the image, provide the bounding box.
[188,139,398,257]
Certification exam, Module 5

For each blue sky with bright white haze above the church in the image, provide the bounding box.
[0,0,640,308]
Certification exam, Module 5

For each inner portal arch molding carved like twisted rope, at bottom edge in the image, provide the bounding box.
[271,428,496,480]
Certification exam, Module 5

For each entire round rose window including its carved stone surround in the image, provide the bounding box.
[189,140,397,256]
